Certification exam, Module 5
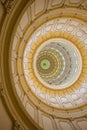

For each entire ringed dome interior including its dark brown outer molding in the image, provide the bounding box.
[2,0,87,130]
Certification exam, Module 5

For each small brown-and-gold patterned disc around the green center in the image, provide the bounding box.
[36,49,62,79]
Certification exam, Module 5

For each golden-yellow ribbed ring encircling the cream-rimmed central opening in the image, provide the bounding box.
[28,31,87,96]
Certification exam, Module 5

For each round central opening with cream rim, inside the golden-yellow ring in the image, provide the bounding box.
[33,38,82,89]
